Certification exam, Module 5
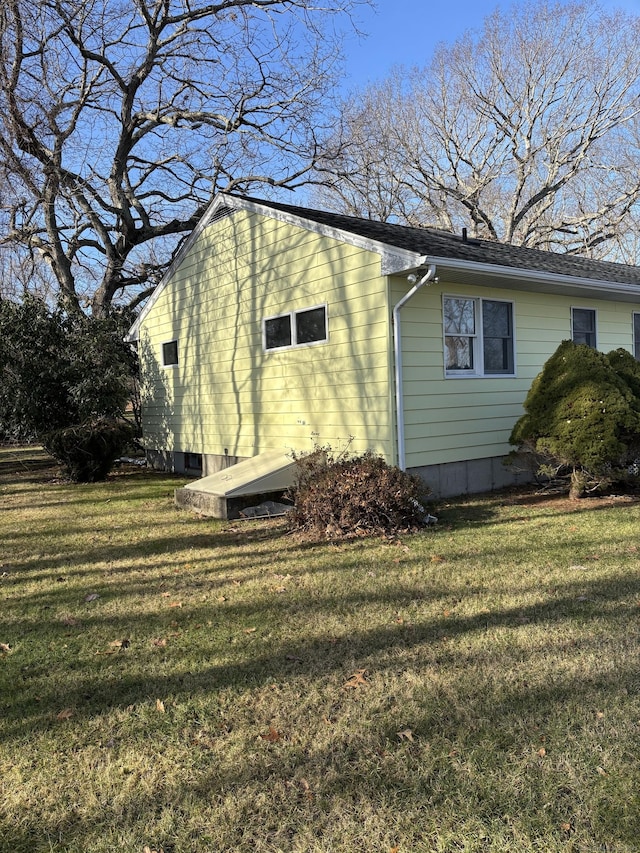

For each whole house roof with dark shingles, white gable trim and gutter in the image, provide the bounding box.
[127,193,640,341]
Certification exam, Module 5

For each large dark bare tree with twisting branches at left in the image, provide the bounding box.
[0,0,365,316]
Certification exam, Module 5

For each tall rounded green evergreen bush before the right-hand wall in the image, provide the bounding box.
[510,341,640,497]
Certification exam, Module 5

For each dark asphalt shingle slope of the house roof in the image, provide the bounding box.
[247,194,640,285]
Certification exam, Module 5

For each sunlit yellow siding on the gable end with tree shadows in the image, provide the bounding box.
[139,211,393,466]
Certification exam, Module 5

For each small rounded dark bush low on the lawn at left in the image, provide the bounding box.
[42,418,134,483]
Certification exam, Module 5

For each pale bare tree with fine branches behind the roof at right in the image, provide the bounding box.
[322,2,640,260]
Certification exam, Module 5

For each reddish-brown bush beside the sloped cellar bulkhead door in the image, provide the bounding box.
[288,447,429,539]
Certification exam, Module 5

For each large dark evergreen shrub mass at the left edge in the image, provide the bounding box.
[0,297,137,481]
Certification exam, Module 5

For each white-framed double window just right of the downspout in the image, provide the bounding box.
[443,296,515,376]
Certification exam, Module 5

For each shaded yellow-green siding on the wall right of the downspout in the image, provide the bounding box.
[392,278,639,470]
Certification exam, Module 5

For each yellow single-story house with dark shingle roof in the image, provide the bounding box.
[129,194,640,515]
